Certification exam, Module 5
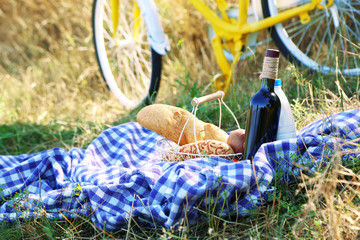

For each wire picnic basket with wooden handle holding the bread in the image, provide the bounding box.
[156,91,242,162]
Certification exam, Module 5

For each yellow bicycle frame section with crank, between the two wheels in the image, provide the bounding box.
[190,0,333,93]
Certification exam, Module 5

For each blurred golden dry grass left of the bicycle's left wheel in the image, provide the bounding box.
[0,0,128,123]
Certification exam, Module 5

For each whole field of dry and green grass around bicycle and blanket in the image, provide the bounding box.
[0,0,360,239]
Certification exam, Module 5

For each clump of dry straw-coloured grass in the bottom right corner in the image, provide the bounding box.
[292,162,360,239]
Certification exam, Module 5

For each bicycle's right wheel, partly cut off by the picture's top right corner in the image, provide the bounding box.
[262,0,360,76]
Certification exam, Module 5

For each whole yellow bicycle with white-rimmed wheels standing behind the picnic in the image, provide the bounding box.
[93,0,360,108]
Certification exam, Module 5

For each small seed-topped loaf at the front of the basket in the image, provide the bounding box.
[163,140,235,162]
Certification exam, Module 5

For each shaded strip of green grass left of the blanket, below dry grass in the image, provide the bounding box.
[0,120,107,155]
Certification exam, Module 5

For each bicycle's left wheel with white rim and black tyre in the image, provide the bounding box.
[92,0,161,108]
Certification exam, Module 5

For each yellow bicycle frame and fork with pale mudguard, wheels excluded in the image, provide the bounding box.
[111,0,334,93]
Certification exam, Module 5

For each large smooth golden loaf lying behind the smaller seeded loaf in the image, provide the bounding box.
[136,104,228,146]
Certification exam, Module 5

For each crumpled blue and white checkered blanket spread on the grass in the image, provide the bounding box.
[0,109,360,230]
